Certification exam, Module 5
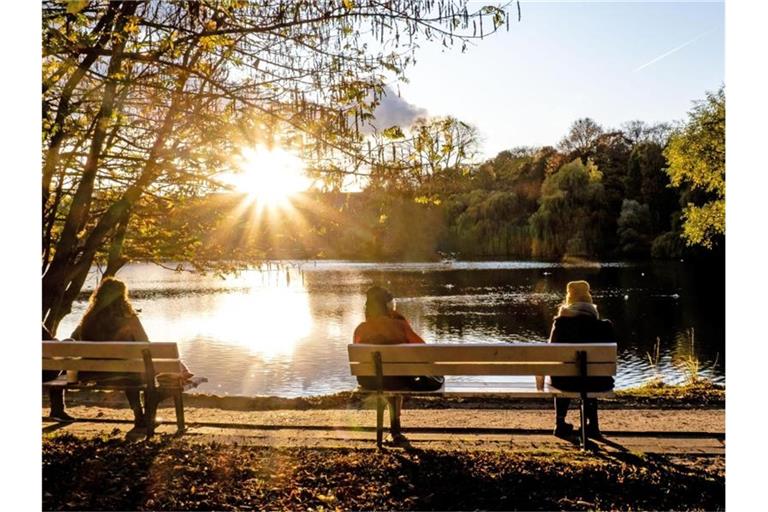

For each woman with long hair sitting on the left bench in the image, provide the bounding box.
[71,277,149,427]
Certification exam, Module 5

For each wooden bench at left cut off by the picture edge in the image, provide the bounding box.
[43,341,207,436]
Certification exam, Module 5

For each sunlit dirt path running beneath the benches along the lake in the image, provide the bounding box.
[43,406,725,459]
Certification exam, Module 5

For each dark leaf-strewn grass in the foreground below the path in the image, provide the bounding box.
[43,435,725,510]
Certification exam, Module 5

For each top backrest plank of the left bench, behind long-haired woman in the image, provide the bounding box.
[43,341,179,359]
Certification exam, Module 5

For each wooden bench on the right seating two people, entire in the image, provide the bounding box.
[348,343,616,447]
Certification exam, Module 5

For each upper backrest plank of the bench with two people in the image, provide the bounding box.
[348,343,616,363]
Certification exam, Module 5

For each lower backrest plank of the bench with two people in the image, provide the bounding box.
[350,362,616,377]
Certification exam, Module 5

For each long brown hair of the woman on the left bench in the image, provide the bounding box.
[76,277,136,341]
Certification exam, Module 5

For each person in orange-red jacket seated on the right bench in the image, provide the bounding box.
[352,286,444,439]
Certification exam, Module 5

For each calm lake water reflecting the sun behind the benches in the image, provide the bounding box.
[58,261,725,397]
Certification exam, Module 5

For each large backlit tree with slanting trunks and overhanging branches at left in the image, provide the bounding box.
[42,0,510,332]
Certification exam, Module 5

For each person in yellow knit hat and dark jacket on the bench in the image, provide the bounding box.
[549,281,616,438]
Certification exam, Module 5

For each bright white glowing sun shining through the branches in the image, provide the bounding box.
[228,146,311,206]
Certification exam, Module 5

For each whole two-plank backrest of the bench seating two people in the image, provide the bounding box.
[348,343,616,377]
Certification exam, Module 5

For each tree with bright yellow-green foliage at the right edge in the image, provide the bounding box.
[664,87,725,249]
